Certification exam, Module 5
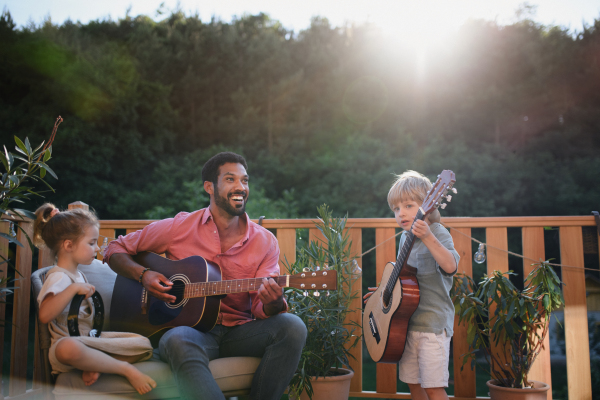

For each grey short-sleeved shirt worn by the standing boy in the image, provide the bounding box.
[398,222,460,336]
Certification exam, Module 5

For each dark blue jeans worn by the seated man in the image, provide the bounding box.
[159,313,306,400]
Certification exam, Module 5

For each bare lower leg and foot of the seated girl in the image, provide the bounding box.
[56,338,156,394]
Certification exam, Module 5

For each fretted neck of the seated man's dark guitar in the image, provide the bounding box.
[184,275,290,299]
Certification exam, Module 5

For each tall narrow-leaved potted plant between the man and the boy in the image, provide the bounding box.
[285,205,361,400]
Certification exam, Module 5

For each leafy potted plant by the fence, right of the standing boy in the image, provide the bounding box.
[451,261,564,399]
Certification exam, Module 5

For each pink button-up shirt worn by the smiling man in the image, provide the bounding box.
[104,208,287,326]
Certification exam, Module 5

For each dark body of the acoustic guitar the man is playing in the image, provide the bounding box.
[110,253,224,337]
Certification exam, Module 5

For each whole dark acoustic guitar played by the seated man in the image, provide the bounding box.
[110,252,337,337]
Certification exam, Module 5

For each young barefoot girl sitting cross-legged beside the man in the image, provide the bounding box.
[33,204,156,394]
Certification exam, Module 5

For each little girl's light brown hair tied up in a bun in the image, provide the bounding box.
[33,203,100,254]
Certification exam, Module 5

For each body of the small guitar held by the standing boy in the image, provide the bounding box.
[363,262,420,363]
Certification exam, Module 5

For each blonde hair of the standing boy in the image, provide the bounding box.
[388,170,440,223]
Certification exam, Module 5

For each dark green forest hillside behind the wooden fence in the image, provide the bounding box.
[0,10,600,219]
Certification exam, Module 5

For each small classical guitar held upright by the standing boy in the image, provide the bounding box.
[363,170,456,363]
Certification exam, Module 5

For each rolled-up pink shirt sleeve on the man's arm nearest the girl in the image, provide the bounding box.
[104,218,174,263]
